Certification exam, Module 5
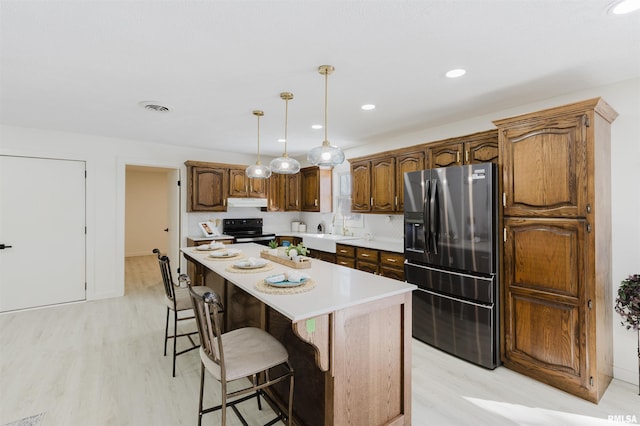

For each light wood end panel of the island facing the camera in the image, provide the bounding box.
[326,294,411,425]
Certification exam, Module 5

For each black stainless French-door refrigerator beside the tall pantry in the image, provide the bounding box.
[404,163,500,369]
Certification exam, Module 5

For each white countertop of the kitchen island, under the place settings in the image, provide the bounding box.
[181,243,417,322]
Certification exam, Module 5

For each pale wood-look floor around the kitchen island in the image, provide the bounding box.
[0,256,640,426]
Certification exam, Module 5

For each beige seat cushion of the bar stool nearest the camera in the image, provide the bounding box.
[200,327,289,381]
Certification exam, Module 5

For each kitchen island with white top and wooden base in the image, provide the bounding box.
[182,244,415,425]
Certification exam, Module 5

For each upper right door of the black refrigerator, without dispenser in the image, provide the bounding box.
[427,163,497,274]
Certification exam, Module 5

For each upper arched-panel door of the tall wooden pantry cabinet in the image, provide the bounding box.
[502,116,587,217]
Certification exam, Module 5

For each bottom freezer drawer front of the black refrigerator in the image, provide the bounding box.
[413,289,499,369]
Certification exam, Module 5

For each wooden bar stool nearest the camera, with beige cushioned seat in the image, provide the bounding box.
[189,286,293,426]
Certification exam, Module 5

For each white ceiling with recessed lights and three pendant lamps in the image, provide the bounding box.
[0,0,640,156]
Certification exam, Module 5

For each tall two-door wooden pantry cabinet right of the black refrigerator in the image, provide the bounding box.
[494,98,617,403]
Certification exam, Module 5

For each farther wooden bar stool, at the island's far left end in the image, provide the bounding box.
[153,248,200,377]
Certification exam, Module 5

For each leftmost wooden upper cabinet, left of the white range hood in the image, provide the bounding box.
[185,161,229,212]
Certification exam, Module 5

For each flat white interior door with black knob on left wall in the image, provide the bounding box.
[0,155,86,312]
